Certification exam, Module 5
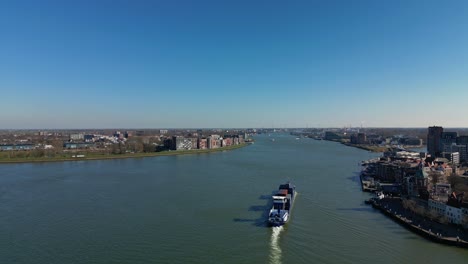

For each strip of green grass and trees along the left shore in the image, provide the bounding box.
[0,143,248,163]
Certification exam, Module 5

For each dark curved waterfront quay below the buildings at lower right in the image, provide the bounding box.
[370,198,468,248]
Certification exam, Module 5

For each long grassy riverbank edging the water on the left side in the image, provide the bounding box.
[0,143,250,164]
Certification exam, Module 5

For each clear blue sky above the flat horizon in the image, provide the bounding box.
[0,0,468,128]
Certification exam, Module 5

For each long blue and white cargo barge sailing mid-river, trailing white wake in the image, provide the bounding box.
[268,182,296,226]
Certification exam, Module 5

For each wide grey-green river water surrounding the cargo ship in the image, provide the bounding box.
[0,134,468,263]
